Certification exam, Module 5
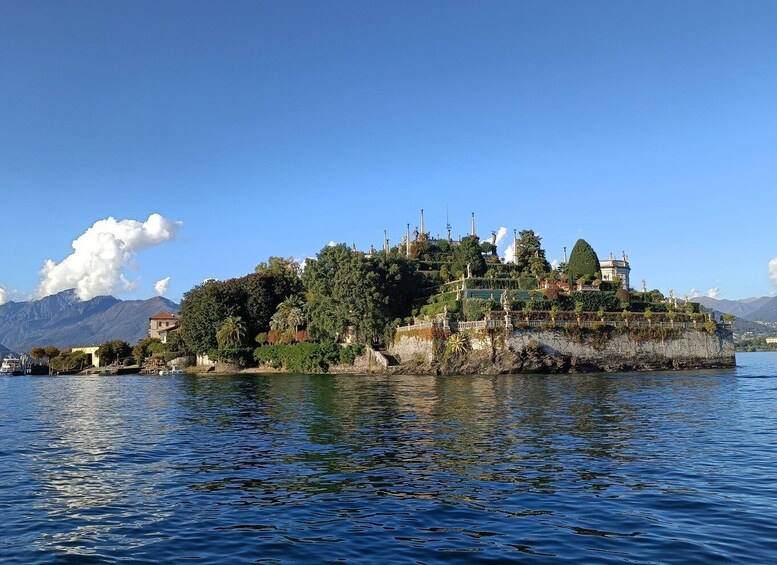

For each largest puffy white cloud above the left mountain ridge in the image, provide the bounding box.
[37,214,183,300]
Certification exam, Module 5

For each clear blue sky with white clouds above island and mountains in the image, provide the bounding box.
[0,0,777,302]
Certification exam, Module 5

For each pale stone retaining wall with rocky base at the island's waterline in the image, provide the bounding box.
[389,329,735,375]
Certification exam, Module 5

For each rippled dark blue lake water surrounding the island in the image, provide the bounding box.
[0,353,777,563]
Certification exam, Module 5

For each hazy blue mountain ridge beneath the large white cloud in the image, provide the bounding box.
[0,290,178,352]
